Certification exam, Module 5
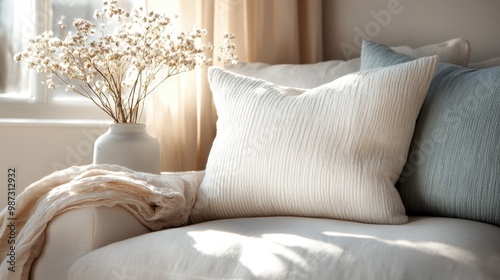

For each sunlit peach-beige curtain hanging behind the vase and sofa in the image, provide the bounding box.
[145,0,323,171]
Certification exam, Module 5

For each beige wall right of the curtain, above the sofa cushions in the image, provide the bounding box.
[323,0,500,62]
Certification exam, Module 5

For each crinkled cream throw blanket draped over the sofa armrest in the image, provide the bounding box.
[0,165,204,279]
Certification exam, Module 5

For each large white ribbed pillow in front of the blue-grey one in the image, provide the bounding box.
[191,57,437,224]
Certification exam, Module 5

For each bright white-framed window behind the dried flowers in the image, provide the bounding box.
[0,0,137,119]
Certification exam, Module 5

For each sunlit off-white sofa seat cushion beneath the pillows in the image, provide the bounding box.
[68,217,500,280]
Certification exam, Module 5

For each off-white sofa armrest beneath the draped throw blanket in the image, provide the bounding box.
[30,206,150,280]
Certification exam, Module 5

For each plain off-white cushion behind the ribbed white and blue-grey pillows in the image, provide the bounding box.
[227,38,470,88]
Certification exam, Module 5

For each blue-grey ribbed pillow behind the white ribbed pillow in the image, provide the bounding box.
[361,41,500,226]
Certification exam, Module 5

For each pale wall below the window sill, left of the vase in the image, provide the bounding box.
[0,120,108,208]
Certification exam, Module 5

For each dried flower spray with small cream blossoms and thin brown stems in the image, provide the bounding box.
[14,0,237,123]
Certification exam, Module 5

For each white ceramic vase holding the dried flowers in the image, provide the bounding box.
[94,123,160,174]
